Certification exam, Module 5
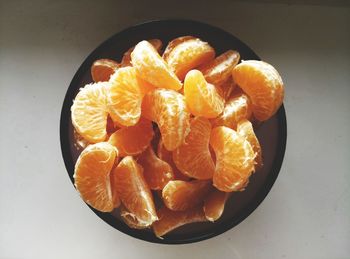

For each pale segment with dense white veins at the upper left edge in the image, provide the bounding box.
[71,82,109,143]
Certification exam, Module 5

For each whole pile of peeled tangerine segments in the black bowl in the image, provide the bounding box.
[71,36,284,237]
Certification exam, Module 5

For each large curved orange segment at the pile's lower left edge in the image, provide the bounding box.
[73,142,118,212]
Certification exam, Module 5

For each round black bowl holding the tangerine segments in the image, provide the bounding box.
[60,20,287,244]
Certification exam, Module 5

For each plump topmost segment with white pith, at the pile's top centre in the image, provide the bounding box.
[163,36,215,80]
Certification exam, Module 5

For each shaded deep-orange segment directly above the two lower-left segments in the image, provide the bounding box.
[108,118,154,157]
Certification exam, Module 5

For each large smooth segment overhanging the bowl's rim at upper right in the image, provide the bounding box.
[232,60,284,121]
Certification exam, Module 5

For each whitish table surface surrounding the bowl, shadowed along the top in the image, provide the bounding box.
[0,0,350,259]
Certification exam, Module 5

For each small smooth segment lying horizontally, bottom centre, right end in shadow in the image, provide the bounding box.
[162,180,211,211]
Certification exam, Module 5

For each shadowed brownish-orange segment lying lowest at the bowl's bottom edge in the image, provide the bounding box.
[152,207,207,237]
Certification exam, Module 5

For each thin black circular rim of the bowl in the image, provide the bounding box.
[59,19,287,244]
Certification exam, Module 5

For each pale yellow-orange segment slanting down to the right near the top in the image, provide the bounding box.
[131,40,182,90]
